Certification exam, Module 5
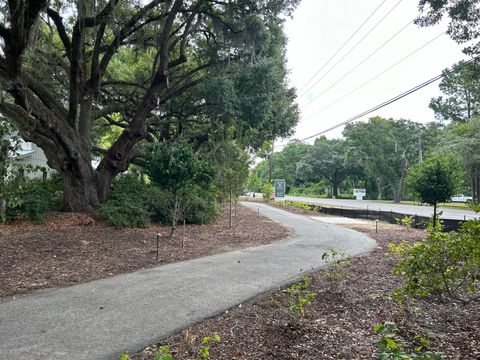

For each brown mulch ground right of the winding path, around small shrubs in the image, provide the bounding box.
[133,207,480,360]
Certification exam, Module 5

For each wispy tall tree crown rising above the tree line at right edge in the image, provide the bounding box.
[430,61,480,122]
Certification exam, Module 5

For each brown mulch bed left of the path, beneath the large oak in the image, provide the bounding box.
[0,205,290,299]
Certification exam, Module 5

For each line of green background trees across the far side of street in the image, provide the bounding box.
[250,61,480,203]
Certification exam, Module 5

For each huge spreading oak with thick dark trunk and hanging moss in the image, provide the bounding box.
[0,0,298,211]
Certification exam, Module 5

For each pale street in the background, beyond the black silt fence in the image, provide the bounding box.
[286,196,480,220]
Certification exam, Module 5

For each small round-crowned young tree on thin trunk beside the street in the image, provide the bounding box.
[408,154,461,225]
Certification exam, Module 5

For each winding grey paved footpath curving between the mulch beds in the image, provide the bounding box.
[0,203,376,360]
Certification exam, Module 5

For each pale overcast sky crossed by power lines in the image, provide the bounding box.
[277,0,466,150]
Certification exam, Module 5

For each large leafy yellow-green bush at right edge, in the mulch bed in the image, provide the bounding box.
[389,219,480,302]
